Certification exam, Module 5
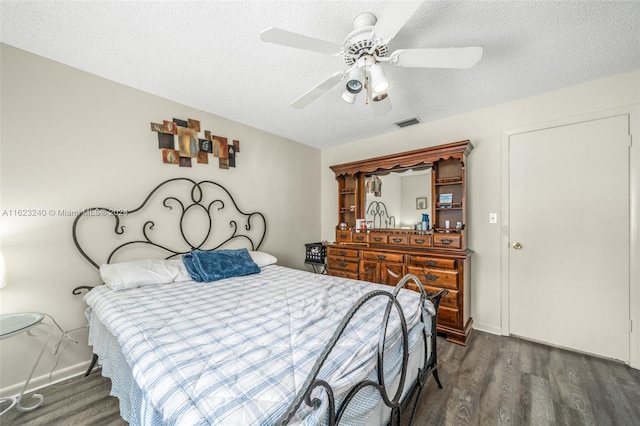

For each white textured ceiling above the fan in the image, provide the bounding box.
[0,0,640,148]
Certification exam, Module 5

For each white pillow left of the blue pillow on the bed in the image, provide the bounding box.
[100,259,191,290]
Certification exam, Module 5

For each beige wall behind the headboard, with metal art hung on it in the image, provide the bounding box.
[0,45,320,396]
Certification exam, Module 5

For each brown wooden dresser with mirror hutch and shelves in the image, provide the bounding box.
[326,141,473,345]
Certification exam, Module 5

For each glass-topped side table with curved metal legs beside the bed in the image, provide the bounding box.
[0,312,51,416]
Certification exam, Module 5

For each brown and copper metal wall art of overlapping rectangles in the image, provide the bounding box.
[151,118,240,169]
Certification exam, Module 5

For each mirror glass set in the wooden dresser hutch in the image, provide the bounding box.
[364,169,432,229]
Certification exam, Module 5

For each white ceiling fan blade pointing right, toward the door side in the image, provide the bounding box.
[389,46,482,68]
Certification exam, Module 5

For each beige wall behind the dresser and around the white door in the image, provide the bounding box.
[321,71,640,368]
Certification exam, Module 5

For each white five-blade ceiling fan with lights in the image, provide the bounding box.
[260,1,482,114]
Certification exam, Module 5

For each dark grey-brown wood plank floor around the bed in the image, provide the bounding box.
[5,331,640,426]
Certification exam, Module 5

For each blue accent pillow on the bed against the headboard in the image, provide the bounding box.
[182,249,260,282]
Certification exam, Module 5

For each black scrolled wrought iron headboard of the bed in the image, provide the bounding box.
[72,178,267,268]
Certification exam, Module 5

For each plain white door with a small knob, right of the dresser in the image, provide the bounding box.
[509,115,630,362]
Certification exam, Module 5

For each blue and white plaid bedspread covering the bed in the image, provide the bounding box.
[85,265,430,426]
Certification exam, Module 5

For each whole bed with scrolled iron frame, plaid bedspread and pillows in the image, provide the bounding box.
[72,178,442,425]
